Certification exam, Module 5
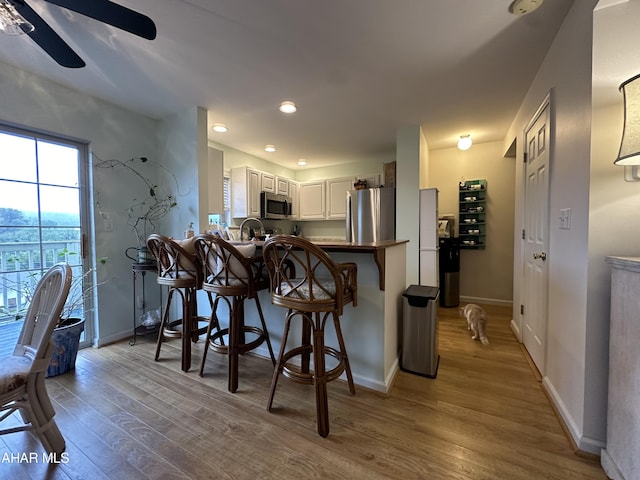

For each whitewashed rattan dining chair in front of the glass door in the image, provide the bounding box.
[0,263,71,460]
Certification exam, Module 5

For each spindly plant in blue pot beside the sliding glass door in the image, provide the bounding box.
[2,251,107,377]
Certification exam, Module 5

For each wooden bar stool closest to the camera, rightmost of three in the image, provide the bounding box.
[262,235,357,437]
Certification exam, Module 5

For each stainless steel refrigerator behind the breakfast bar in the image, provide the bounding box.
[346,187,396,243]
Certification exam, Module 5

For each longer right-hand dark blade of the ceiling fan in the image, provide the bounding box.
[46,0,156,40]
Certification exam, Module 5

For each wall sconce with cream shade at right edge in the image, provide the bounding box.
[613,75,640,165]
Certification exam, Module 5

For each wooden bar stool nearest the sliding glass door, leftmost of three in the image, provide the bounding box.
[147,233,212,372]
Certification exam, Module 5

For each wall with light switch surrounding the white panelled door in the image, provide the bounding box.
[503,0,607,453]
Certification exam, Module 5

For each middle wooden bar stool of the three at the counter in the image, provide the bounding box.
[194,234,275,393]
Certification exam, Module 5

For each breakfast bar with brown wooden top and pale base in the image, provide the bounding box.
[203,239,408,392]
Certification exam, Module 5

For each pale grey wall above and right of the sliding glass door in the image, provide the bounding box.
[0,60,164,343]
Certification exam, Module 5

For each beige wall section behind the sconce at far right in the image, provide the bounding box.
[585,1,640,454]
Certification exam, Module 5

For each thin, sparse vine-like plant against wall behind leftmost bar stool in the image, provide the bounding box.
[92,153,178,263]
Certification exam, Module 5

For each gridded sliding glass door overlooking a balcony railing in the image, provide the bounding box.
[0,124,93,350]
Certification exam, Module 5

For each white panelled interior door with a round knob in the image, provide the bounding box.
[522,100,551,374]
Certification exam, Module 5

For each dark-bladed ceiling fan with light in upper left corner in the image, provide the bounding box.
[0,0,156,68]
